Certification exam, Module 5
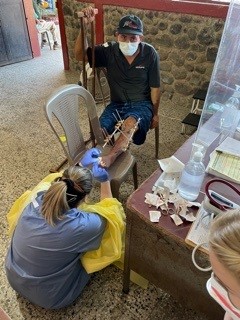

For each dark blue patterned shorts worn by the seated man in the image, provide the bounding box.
[99,101,153,145]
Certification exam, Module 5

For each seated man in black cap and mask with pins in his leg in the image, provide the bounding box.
[75,7,160,167]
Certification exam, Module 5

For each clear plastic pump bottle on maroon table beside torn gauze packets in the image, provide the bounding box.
[178,150,205,201]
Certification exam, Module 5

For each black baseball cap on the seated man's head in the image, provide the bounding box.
[117,15,143,36]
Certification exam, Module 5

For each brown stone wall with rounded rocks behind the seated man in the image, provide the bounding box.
[63,0,224,104]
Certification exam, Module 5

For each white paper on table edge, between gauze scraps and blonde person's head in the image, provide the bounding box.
[185,207,211,252]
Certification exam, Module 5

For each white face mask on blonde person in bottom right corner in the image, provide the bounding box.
[207,273,240,320]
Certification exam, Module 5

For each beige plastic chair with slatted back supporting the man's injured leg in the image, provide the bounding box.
[45,84,138,198]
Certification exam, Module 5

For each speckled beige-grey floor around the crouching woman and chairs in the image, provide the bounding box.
[0,47,206,320]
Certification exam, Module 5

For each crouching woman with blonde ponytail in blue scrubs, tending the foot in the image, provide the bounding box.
[5,159,112,309]
